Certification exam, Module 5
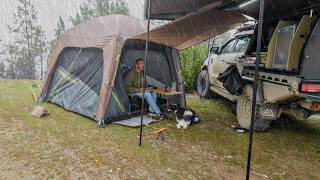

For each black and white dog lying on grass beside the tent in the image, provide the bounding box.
[176,107,199,129]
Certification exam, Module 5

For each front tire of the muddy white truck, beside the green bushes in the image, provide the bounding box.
[197,70,213,98]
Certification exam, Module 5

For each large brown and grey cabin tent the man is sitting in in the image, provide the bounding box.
[39,15,185,122]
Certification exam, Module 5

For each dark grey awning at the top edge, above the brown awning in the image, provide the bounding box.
[145,0,222,20]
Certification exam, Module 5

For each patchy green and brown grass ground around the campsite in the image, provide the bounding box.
[0,80,320,179]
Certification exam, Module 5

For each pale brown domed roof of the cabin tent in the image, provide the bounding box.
[59,15,146,47]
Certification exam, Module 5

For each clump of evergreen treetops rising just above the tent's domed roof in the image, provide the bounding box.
[70,0,129,25]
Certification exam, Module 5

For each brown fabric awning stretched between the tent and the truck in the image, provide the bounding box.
[132,4,246,50]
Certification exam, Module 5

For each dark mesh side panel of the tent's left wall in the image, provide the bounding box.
[48,48,103,119]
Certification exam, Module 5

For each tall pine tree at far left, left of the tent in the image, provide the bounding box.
[7,0,47,79]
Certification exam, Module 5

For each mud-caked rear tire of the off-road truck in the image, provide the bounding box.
[237,85,271,131]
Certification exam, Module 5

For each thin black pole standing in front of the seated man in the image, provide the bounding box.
[139,0,151,146]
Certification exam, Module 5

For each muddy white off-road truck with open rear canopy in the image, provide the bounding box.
[197,7,320,131]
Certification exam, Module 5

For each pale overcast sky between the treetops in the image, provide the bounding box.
[0,0,144,43]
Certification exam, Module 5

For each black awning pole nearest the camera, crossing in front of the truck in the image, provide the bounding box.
[246,0,265,180]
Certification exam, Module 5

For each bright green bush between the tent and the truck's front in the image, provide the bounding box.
[180,43,208,91]
